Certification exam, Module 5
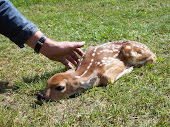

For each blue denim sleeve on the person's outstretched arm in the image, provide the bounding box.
[0,0,38,48]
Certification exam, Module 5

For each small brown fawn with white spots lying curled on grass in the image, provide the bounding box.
[38,41,156,101]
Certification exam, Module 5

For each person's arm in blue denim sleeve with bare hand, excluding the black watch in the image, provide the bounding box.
[0,0,84,68]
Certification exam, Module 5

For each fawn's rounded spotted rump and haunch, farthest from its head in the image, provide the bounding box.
[121,42,156,67]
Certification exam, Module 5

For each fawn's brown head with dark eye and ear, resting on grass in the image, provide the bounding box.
[38,72,97,101]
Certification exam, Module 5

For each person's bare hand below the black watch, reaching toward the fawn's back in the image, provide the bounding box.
[40,38,85,69]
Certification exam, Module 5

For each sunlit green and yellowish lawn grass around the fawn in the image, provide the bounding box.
[0,0,170,127]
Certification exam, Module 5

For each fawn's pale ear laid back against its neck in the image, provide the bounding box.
[80,77,97,89]
